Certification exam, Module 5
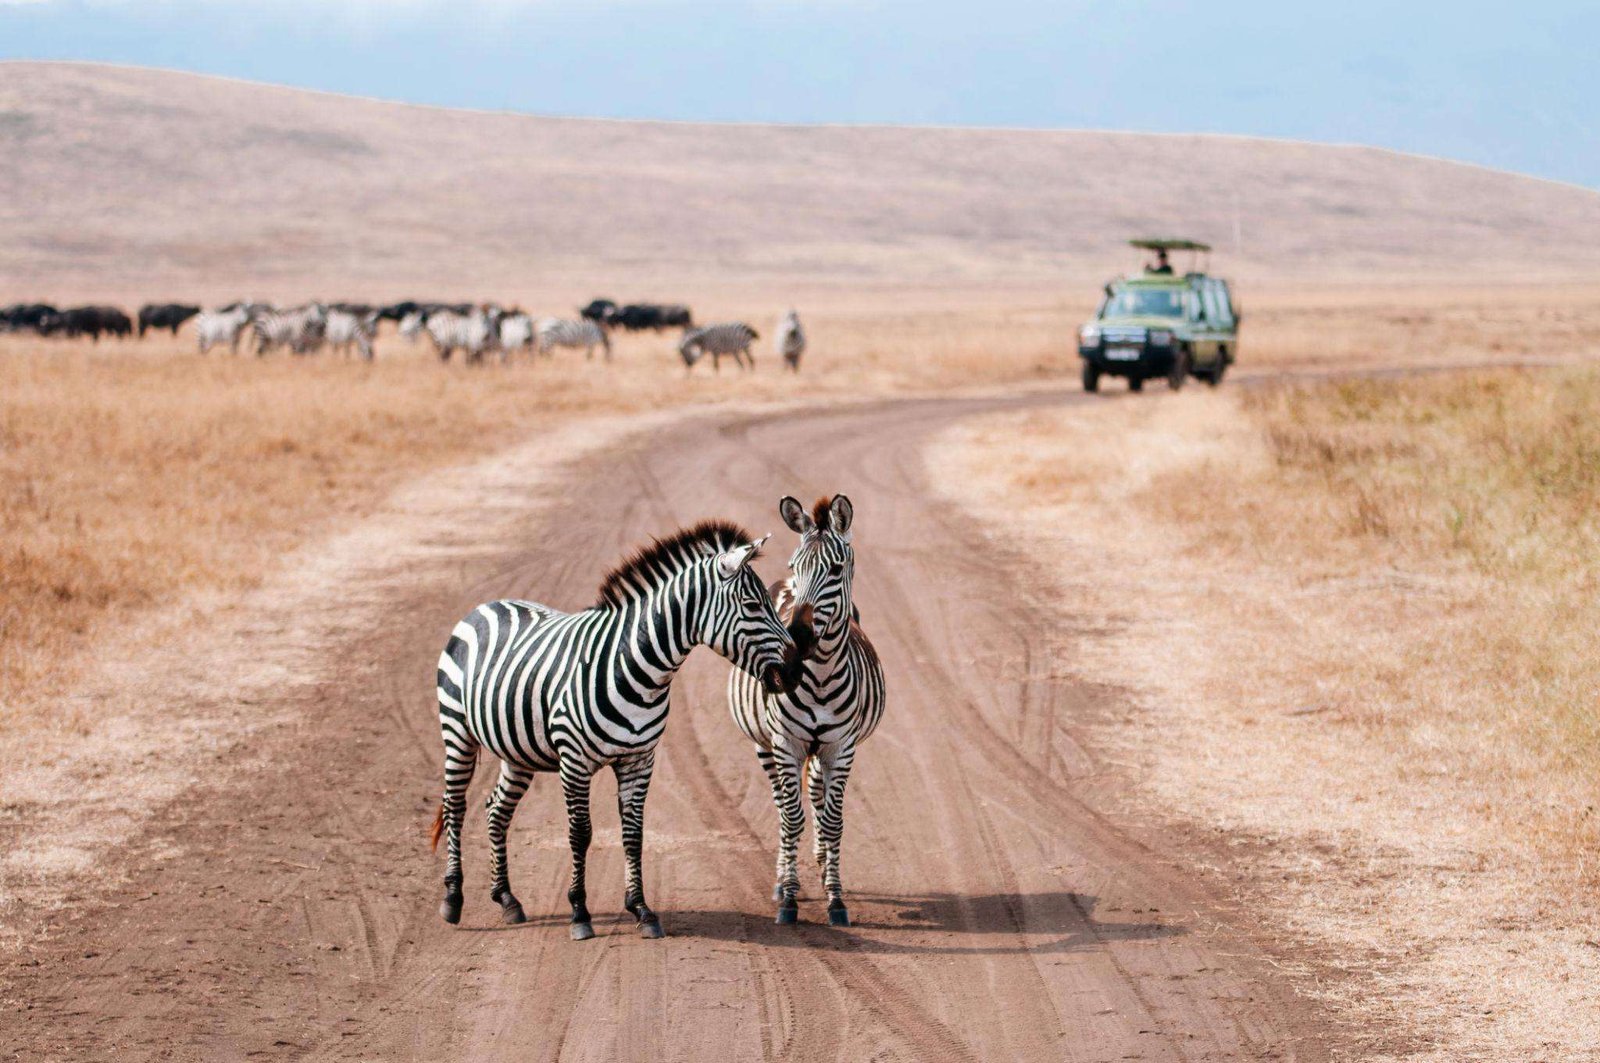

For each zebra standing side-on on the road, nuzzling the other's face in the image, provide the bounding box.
[432,520,795,941]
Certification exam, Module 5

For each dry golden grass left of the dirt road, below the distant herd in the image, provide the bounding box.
[0,296,1075,727]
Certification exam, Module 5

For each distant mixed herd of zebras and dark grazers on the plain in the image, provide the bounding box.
[0,299,805,371]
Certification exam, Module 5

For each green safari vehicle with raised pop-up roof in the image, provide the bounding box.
[1078,240,1240,391]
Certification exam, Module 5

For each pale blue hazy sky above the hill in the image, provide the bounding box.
[0,0,1600,189]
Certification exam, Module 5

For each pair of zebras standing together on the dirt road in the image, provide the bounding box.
[432,495,885,941]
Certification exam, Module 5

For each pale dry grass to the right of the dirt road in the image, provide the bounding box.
[934,368,1600,1060]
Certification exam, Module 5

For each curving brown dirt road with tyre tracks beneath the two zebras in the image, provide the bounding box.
[0,395,1331,1061]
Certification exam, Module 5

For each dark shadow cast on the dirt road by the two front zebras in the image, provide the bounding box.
[464,892,1187,956]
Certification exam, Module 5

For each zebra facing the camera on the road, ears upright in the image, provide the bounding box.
[728,495,885,927]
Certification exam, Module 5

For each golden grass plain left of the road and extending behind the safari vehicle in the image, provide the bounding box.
[9,278,1600,739]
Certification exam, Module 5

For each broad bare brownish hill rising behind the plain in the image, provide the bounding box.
[0,62,1600,301]
